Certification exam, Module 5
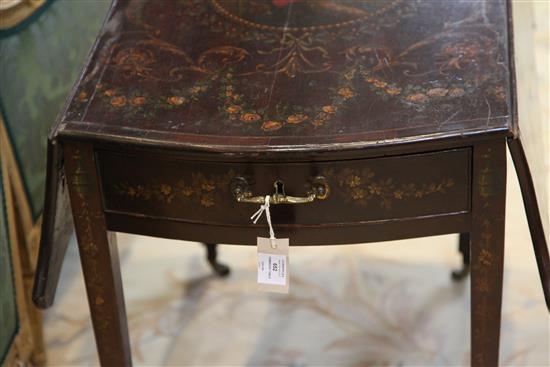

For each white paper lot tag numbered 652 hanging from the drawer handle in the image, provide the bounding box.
[257,237,289,293]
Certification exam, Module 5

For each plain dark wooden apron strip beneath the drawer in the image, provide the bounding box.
[106,212,471,246]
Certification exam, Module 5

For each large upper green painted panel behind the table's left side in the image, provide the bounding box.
[0,0,111,218]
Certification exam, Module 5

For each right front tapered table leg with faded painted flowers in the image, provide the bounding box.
[471,140,506,367]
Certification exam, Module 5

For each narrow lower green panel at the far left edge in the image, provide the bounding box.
[0,152,18,365]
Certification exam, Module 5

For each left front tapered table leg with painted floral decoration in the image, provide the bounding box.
[64,143,132,367]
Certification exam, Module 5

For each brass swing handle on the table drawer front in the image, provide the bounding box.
[231,176,330,205]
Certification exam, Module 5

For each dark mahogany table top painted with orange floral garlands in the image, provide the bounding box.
[53,0,515,152]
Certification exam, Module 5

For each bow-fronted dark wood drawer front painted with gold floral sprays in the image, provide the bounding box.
[96,148,471,226]
